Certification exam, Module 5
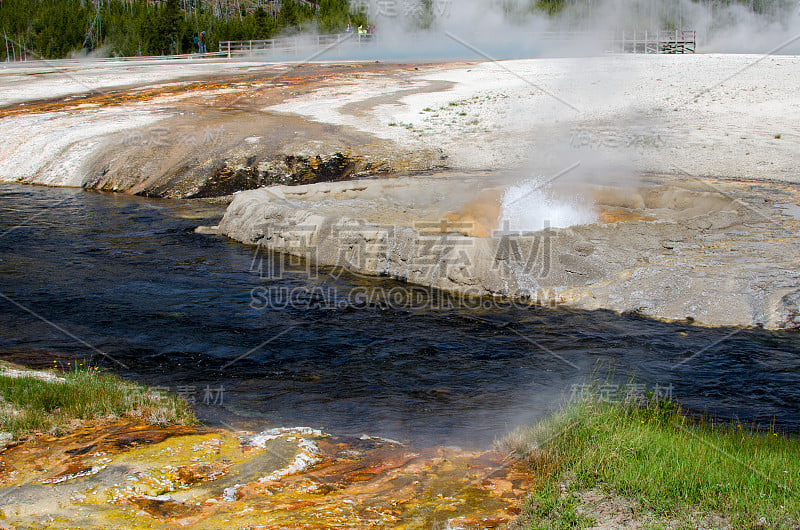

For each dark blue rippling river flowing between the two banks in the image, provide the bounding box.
[0,185,800,446]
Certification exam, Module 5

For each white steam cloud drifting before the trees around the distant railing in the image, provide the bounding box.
[298,0,800,60]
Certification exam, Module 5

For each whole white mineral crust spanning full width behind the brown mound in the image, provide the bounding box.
[0,54,800,185]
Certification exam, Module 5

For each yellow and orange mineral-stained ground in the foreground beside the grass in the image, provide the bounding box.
[0,421,531,529]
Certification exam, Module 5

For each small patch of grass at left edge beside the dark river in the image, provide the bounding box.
[0,358,195,437]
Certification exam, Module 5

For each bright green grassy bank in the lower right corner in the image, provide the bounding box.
[499,386,800,528]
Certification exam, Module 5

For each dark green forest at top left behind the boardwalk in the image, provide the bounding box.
[0,0,366,60]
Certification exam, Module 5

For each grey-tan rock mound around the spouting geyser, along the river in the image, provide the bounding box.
[218,175,800,329]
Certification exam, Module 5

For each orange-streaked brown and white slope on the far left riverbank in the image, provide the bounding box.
[0,61,444,198]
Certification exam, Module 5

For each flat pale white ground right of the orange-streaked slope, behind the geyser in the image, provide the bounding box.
[269,54,800,182]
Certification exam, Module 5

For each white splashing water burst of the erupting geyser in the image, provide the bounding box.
[500,179,598,232]
